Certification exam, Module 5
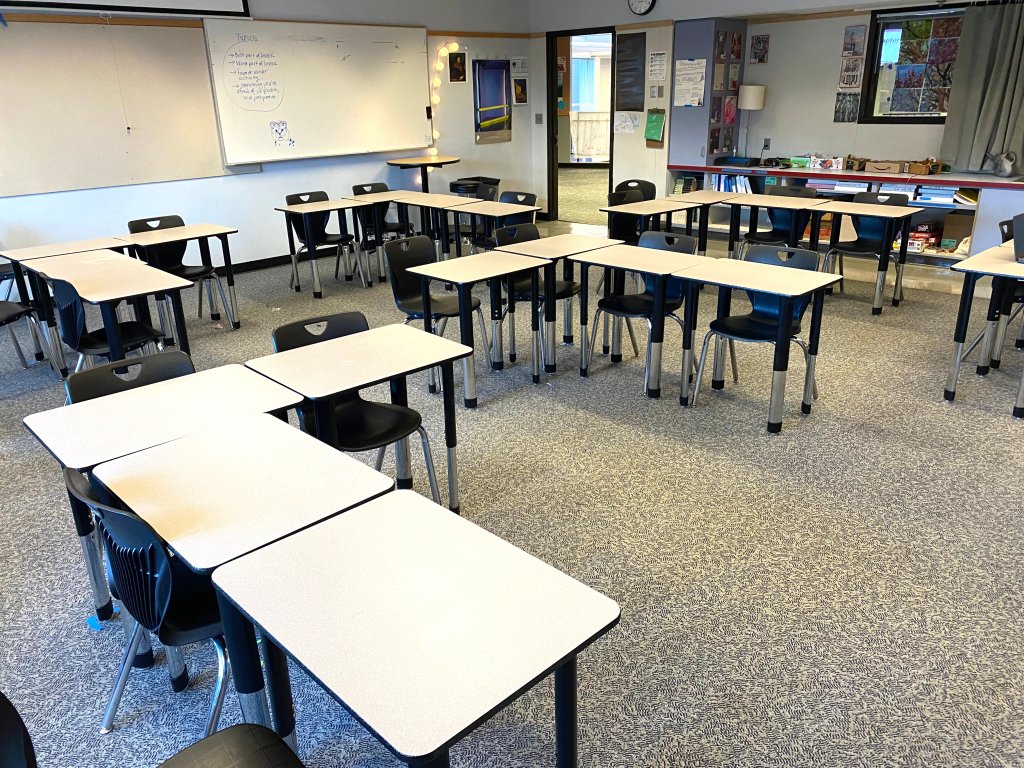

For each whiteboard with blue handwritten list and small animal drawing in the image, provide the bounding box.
[204,18,431,165]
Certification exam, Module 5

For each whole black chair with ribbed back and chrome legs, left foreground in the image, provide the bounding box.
[63,469,229,736]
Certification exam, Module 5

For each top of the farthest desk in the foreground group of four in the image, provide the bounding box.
[246,325,473,400]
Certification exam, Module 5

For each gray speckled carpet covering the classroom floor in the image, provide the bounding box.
[0,243,1024,768]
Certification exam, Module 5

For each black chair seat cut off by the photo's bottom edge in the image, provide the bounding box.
[161,723,303,768]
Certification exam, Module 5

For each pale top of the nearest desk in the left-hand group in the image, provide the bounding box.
[26,251,191,304]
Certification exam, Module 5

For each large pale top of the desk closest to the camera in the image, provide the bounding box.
[213,490,620,758]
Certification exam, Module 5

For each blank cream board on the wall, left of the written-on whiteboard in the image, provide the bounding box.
[0,19,235,197]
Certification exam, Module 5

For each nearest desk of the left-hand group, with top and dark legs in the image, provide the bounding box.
[25,251,191,360]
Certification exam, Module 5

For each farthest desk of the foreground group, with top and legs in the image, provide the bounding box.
[246,324,473,513]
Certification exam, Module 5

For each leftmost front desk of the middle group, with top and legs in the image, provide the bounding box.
[409,251,554,408]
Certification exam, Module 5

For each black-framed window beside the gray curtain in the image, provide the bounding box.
[860,7,964,123]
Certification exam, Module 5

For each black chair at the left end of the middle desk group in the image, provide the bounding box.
[384,234,490,349]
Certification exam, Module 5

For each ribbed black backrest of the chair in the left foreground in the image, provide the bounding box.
[63,468,173,635]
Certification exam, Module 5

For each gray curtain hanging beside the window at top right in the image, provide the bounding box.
[941,4,1024,173]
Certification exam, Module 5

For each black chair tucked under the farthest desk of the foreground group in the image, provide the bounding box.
[272,312,440,504]
